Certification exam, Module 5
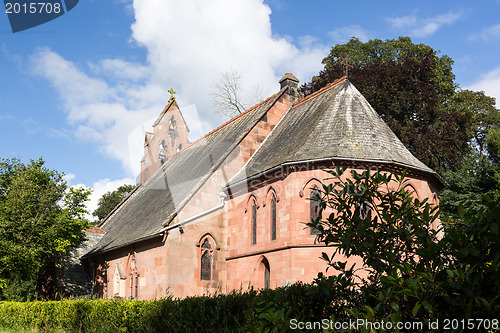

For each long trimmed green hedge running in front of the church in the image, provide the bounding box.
[0,283,348,332]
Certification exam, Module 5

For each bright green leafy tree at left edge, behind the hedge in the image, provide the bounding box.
[0,158,90,300]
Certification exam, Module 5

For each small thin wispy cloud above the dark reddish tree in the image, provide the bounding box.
[387,11,464,37]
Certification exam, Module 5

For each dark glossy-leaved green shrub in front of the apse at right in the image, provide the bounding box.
[309,168,500,322]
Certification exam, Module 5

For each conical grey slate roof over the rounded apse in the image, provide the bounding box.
[230,78,435,184]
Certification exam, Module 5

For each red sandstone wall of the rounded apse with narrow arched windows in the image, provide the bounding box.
[226,169,437,290]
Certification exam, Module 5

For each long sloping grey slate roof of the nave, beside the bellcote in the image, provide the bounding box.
[84,87,289,257]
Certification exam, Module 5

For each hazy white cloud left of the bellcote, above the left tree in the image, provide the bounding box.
[31,49,164,175]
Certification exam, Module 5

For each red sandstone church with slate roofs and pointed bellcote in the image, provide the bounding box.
[83,73,443,300]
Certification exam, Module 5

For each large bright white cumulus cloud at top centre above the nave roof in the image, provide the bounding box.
[132,0,326,111]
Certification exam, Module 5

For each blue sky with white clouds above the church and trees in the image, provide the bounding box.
[0,0,500,217]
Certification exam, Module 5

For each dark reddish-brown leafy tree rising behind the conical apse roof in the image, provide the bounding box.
[302,38,471,172]
